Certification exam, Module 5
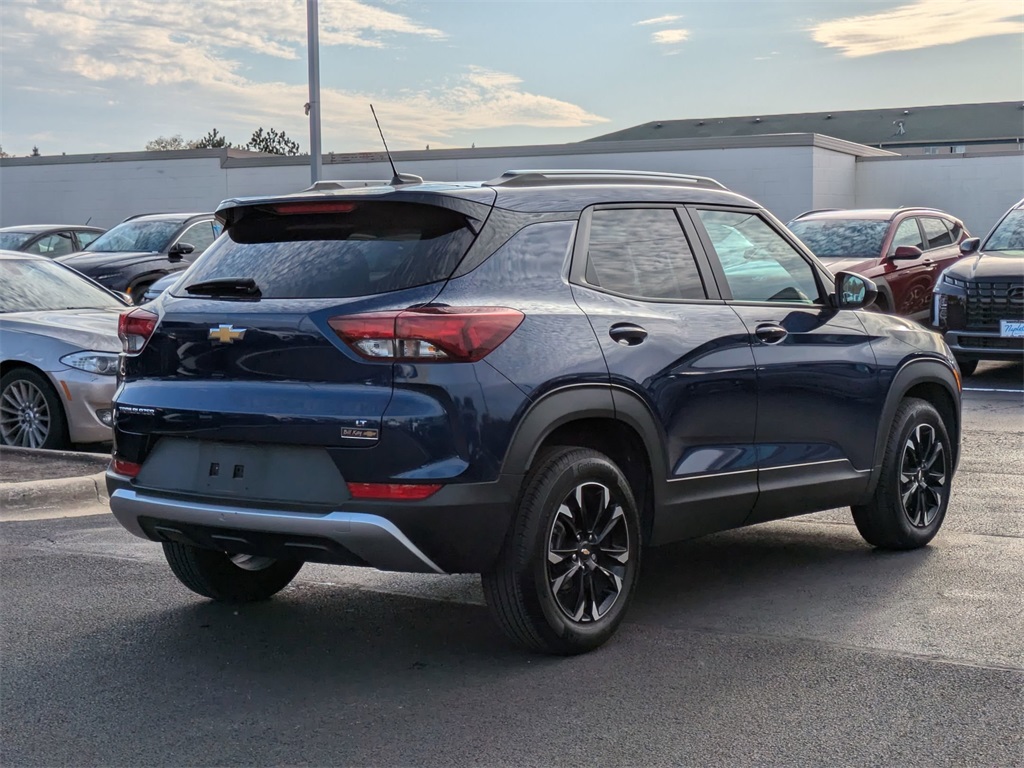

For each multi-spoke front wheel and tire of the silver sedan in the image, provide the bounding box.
[0,368,68,449]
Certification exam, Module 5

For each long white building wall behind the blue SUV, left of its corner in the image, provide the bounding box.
[0,144,823,226]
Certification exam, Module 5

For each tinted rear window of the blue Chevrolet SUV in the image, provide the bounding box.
[174,201,475,299]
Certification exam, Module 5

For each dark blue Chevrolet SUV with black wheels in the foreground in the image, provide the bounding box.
[108,171,961,653]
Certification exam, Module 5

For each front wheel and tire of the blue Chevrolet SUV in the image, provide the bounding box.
[853,397,952,550]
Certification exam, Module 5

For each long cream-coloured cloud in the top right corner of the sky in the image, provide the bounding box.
[809,0,1024,58]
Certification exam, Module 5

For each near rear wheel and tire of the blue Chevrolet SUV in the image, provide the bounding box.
[482,447,640,655]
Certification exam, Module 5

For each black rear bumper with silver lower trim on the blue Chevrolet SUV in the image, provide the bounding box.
[106,472,520,573]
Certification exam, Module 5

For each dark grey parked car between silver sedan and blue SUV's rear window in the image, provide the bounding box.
[59,213,220,303]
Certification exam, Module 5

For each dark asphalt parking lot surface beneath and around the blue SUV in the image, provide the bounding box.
[0,364,1024,766]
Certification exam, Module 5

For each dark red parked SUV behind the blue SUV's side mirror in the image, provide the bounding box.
[788,208,971,321]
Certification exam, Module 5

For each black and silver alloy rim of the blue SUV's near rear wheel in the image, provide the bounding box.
[547,482,630,623]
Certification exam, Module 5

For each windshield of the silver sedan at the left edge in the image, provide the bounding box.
[0,258,125,312]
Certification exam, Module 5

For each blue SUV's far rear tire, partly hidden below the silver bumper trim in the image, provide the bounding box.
[164,542,302,603]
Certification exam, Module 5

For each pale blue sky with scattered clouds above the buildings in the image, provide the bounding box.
[0,0,1024,156]
